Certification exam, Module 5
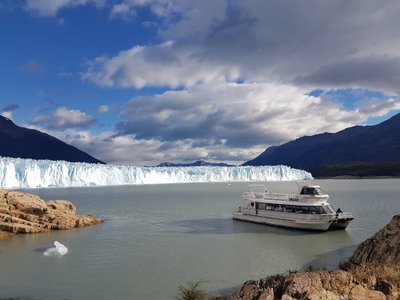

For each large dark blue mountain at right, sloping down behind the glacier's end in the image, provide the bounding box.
[244,114,400,176]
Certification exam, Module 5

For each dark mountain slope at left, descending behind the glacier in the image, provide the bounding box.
[0,116,103,163]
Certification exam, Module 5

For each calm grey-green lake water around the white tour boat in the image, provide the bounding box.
[0,179,400,300]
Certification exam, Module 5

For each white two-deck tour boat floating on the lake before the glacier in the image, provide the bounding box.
[233,184,353,231]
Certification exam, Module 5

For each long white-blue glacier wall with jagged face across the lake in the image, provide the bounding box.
[0,157,313,188]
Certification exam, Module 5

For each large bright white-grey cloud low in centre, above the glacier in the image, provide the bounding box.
[111,83,380,163]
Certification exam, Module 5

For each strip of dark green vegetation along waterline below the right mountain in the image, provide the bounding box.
[308,162,400,178]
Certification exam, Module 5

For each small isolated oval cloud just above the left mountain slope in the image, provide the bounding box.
[31,107,95,130]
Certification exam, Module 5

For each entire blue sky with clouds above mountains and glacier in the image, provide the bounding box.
[0,0,400,166]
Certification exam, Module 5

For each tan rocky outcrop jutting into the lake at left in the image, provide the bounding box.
[0,189,103,240]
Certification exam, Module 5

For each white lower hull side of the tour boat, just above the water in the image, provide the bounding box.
[233,212,333,231]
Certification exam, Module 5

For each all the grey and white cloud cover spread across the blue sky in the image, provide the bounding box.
[19,0,400,164]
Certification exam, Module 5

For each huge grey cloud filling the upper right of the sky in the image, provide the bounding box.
[84,0,400,93]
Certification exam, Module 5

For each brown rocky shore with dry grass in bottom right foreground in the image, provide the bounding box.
[227,215,400,300]
